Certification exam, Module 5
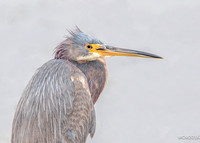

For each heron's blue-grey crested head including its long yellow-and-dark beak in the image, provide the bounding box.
[55,27,162,62]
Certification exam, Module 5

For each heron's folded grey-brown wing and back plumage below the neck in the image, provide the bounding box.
[12,59,95,143]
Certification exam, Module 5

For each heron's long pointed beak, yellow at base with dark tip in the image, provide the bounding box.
[91,44,162,59]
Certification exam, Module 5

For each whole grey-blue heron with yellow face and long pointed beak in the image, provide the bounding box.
[12,28,161,143]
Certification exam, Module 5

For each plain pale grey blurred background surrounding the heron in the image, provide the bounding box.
[0,0,200,143]
